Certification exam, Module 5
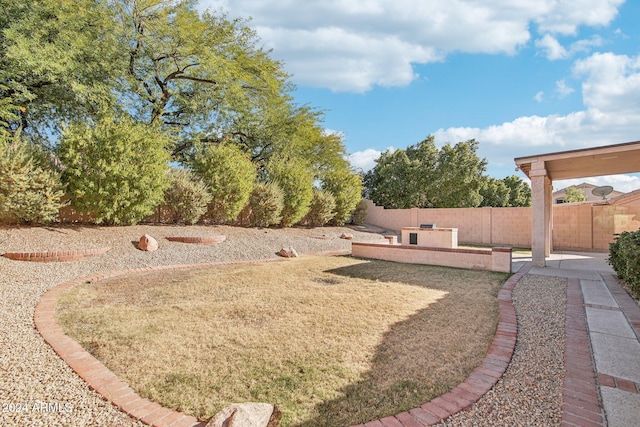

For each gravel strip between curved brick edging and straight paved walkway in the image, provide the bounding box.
[439,275,566,426]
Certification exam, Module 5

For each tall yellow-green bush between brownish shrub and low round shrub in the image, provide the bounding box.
[191,144,256,223]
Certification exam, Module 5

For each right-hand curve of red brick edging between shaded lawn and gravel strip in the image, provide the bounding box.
[352,264,531,427]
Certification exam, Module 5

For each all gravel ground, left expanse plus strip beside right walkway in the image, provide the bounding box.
[0,225,565,426]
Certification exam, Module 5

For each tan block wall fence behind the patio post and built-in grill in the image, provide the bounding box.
[366,200,640,251]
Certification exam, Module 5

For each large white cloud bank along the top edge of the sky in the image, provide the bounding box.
[200,0,624,92]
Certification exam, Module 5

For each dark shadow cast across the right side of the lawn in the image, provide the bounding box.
[298,261,506,427]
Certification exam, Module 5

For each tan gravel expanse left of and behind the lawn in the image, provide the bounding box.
[0,225,383,426]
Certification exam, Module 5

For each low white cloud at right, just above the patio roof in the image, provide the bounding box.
[434,50,640,184]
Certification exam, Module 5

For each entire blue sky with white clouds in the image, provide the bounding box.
[200,0,640,192]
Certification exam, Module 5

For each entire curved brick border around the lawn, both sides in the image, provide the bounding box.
[34,251,530,427]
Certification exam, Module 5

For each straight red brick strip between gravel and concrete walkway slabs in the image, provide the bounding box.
[562,278,606,427]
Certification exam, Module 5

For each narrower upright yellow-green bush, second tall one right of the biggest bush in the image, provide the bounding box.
[266,157,314,227]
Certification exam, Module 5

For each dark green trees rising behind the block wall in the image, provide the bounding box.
[365,136,487,209]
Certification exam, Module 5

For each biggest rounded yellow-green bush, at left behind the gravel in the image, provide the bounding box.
[59,116,169,224]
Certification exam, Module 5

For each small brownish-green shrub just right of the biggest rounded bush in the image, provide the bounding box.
[164,169,211,224]
